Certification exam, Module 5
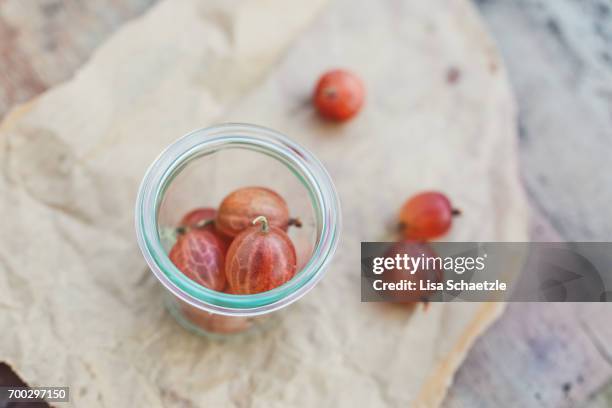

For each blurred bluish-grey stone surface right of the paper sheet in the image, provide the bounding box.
[444,0,612,407]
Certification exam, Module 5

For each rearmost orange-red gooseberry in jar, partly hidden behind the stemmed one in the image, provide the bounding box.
[215,187,289,237]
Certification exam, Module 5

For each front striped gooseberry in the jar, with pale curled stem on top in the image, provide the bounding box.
[225,220,297,295]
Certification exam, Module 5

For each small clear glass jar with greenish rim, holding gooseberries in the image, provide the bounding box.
[135,124,341,335]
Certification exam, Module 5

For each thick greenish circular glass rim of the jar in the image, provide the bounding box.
[135,123,341,316]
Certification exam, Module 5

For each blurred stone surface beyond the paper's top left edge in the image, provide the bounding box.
[0,0,155,118]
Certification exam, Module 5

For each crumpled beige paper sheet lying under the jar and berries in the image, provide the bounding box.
[0,0,527,408]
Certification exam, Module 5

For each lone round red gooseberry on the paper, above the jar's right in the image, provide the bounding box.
[313,69,365,122]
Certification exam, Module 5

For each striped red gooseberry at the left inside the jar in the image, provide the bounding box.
[168,229,226,292]
